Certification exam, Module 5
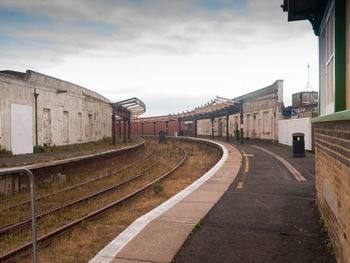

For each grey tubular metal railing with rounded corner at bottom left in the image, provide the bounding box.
[0,167,38,263]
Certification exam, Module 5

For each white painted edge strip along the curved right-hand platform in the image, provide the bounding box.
[89,139,228,263]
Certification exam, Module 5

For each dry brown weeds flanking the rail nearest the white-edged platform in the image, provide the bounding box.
[2,139,220,262]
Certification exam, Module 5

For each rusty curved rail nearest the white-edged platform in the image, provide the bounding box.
[0,147,187,263]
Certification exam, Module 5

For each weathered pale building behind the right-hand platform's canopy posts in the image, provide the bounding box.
[198,80,284,141]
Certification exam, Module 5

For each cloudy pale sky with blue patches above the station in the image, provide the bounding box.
[0,0,318,116]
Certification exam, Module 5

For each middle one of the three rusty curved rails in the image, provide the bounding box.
[0,150,167,236]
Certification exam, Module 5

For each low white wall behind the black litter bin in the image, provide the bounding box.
[278,118,312,151]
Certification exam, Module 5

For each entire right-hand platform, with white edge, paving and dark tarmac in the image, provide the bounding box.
[90,141,335,263]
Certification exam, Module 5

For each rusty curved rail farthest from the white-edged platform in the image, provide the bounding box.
[0,150,154,213]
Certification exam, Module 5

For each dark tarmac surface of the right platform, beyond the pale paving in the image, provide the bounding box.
[172,141,335,263]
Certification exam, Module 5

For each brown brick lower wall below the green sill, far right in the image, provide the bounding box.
[314,121,350,263]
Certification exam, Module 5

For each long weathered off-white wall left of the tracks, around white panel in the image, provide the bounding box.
[0,71,112,154]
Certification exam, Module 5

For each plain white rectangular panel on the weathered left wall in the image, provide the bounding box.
[11,104,33,154]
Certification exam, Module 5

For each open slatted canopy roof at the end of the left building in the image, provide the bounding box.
[111,97,146,119]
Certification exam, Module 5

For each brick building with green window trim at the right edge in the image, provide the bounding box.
[283,0,350,263]
